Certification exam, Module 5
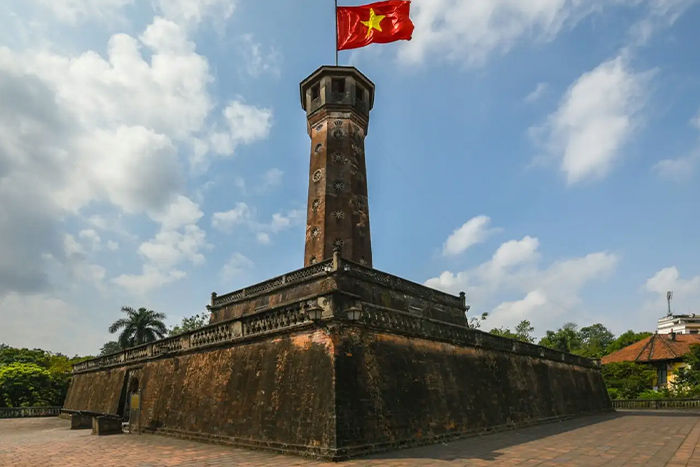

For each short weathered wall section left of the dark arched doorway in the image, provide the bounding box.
[63,368,126,414]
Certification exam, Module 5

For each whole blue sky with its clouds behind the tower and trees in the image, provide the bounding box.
[0,0,700,354]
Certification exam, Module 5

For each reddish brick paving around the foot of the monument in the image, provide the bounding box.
[0,412,700,467]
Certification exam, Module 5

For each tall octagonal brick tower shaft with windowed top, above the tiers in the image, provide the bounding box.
[301,66,374,267]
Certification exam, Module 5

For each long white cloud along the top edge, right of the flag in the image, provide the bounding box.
[399,0,694,65]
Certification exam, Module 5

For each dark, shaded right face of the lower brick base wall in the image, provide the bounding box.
[336,328,610,452]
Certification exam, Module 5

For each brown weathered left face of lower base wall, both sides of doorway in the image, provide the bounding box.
[66,329,335,447]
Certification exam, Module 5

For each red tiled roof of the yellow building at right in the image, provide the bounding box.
[600,334,700,365]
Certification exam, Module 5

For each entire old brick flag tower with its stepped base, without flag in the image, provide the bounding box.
[64,67,611,460]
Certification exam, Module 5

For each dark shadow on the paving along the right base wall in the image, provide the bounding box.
[365,410,699,461]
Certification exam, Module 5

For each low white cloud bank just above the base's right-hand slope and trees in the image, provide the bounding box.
[425,237,618,331]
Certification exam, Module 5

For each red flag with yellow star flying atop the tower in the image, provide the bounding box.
[336,0,413,50]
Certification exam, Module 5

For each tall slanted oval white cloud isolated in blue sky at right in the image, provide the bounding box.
[532,56,653,184]
